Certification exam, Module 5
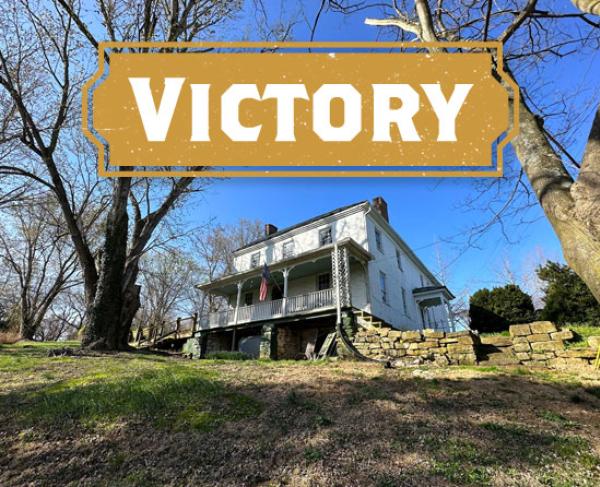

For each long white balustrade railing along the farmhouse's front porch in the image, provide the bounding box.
[200,288,335,329]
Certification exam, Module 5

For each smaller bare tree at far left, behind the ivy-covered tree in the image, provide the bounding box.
[0,198,78,340]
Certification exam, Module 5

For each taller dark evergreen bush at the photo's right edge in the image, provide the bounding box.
[537,261,600,324]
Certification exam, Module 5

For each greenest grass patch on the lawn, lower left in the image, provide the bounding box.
[0,365,261,431]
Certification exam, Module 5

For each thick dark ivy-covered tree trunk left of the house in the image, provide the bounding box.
[82,178,131,350]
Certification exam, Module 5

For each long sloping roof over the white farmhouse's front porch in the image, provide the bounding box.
[196,237,373,291]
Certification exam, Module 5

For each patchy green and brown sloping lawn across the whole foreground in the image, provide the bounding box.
[0,343,600,487]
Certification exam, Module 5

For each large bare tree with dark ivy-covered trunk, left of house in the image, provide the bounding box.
[0,0,268,349]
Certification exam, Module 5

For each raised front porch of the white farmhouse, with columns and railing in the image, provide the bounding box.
[198,239,371,330]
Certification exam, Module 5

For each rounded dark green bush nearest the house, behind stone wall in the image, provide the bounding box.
[469,284,534,333]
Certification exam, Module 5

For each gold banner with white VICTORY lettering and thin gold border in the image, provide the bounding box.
[83,43,518,176]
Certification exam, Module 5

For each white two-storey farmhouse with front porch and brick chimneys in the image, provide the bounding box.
[198,197,454,358]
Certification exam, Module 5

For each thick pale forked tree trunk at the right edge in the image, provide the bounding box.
[513,103,600,302]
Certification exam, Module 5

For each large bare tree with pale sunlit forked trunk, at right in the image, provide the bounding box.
[328,0,600,300]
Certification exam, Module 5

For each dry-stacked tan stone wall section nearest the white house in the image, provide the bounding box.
[353,328,477,365]
